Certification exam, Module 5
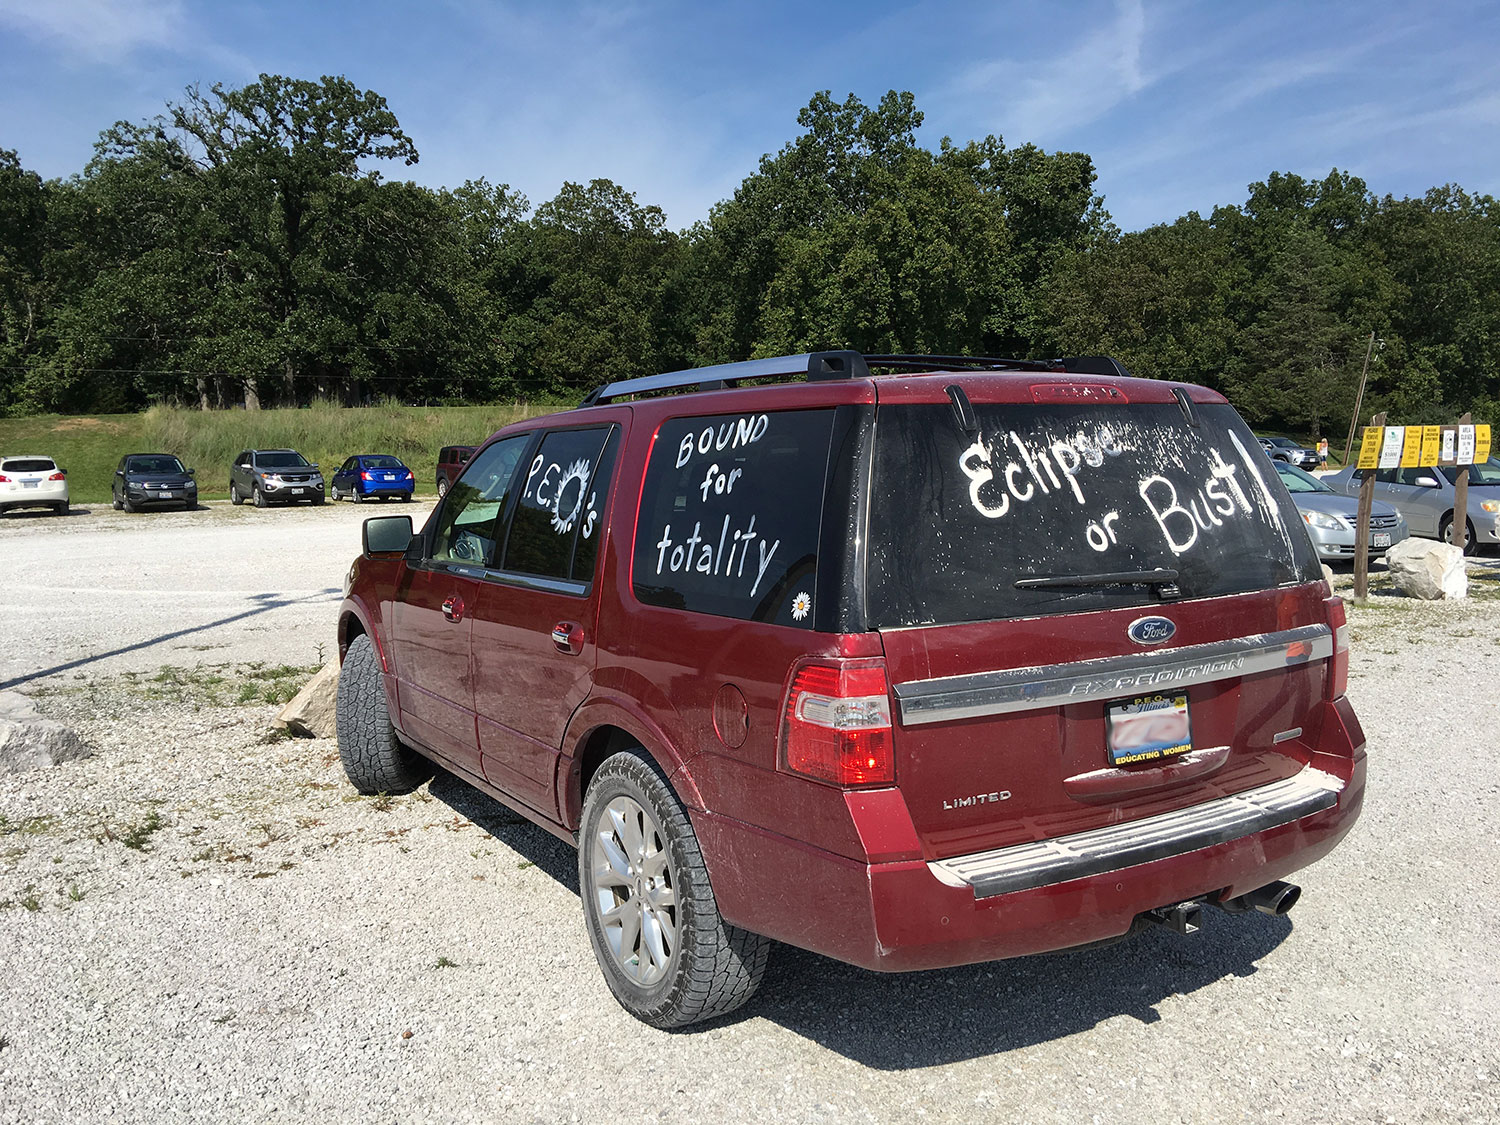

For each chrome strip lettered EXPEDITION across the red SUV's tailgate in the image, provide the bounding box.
[896,626,1334,726]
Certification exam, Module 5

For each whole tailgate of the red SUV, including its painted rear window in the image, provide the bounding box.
[867,380,1332,858]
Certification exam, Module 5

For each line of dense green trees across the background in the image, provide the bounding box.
[0,75,1500,435]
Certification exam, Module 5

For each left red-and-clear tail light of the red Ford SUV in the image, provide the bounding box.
[782,660,896,786]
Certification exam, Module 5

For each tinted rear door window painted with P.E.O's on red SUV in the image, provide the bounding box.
[504,429,614,582]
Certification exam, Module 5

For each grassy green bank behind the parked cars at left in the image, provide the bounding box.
[0,404,564,504]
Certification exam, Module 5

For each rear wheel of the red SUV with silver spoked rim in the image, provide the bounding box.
[578,753,771,1028]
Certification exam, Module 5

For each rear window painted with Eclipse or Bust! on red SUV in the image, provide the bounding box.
[867,404,1322,627]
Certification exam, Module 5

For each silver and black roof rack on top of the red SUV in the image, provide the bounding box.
[579,351,1130,407]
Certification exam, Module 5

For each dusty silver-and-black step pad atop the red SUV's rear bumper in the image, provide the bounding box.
[927,767,1344,899]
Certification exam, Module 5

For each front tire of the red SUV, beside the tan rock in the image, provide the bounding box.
[335,633,432,794]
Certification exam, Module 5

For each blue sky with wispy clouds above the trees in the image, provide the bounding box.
[0,0,1500,230]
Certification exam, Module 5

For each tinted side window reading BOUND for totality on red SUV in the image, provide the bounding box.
[632,410,834,629]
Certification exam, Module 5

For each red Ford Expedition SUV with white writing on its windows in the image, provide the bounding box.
[338,353,1365,1026]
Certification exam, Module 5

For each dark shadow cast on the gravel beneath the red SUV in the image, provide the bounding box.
[429,771,1292,1071]
